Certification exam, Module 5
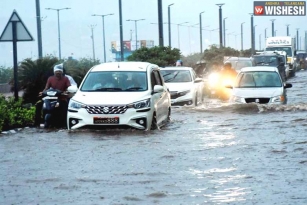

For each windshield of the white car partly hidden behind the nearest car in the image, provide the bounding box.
[160,70,192,83]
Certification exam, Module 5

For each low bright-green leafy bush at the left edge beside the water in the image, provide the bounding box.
[0,95,35,131]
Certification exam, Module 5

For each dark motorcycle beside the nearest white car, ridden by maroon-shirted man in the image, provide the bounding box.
[42,88,67,128]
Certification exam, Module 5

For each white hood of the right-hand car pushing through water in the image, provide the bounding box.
[233,87,283,98]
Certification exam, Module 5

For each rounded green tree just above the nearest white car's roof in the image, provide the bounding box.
[127,46,180,67]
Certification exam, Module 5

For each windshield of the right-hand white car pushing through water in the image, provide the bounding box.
[234,71,282,88]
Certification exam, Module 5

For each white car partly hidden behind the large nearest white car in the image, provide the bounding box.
[161,66,204,106]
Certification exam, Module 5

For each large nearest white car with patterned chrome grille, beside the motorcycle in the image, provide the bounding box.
[67,62,171,130]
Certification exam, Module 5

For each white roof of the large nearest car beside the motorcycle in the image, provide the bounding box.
[91,62,158,72]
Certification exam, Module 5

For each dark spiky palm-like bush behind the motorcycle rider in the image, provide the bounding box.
[18,56,58,103]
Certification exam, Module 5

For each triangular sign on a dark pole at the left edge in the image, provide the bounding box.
[0,10,33,101]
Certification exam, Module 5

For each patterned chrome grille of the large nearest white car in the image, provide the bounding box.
[85,105,128,114]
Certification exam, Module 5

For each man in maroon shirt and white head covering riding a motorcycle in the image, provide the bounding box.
[35,64,71,127]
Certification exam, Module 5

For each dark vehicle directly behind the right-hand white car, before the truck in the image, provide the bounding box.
[253,51,290,82]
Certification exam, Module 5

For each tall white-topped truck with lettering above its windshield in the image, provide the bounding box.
[265,36,297,77]
